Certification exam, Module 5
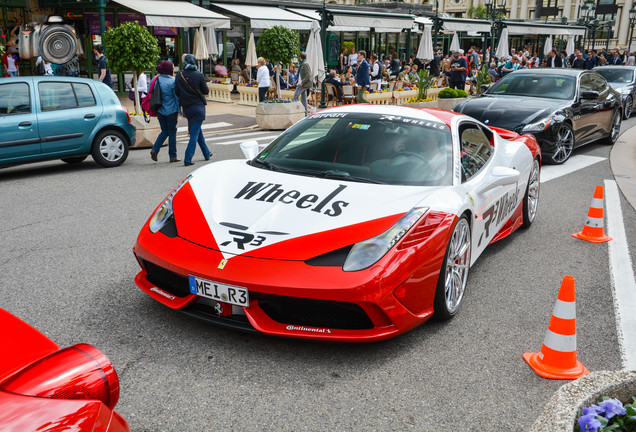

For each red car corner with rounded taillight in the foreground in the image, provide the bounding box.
[0,309,130,432]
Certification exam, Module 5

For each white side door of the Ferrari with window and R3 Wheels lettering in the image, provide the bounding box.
[458,121,519,264]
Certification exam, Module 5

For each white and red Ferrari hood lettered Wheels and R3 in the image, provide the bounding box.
[173,160,436,260]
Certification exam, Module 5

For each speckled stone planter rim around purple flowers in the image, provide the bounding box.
[530,371,636,432]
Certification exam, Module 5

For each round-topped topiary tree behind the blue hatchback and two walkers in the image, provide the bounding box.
[104,22,161,112]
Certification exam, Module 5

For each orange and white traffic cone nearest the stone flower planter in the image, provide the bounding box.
[523,276,590,379]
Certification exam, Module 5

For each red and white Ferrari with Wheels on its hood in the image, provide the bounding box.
[134,105,541,342]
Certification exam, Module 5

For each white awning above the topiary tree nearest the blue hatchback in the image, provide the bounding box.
[113,0,230,28]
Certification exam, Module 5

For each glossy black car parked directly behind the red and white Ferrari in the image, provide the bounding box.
[454,68,623,164]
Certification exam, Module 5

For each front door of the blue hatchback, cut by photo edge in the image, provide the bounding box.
[0,79,40,165]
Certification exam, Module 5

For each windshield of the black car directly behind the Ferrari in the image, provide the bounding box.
[486,73,576,100]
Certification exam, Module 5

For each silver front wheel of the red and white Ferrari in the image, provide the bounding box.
[444,218,470,314]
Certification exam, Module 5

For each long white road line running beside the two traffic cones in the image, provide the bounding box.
[605,180,636,370]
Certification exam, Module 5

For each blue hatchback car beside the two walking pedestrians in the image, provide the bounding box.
[0,76,136,167]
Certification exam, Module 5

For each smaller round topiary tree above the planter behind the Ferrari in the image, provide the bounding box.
[256,26,300,98]
